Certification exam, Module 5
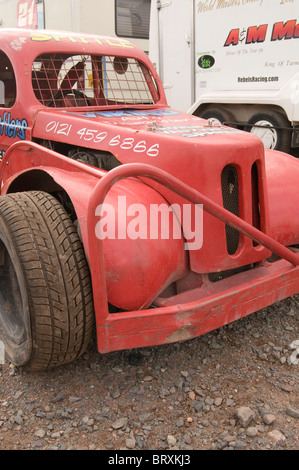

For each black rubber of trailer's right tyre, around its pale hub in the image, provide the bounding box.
[245,111,292,153]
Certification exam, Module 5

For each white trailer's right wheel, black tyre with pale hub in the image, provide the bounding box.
[245,111,291,153]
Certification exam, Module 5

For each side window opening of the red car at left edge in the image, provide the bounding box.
[0,51,17,108]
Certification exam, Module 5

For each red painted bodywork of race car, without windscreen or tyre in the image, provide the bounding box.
[0,30,299,353]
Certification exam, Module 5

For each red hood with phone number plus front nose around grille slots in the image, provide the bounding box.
[33,108,264,272]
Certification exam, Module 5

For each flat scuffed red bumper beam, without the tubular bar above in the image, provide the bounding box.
[96,264,299,353]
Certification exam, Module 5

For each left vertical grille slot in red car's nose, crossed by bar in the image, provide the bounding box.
[221,165,240,255]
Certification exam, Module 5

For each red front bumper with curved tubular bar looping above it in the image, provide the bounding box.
[87,163,299,353]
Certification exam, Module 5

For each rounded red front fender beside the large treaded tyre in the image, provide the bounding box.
[0,142,188,310]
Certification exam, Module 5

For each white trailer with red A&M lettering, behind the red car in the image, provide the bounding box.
[150,0,299,152]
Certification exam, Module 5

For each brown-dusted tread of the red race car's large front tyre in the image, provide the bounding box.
[0,191,94,370]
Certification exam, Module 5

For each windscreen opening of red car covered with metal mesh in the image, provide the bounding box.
[32,54,159,107]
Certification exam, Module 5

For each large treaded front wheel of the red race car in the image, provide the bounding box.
[0,191,93,370]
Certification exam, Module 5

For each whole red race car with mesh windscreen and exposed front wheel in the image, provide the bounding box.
[0,29,299,370]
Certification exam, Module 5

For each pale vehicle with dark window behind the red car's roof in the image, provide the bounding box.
[0,0,151,52]
